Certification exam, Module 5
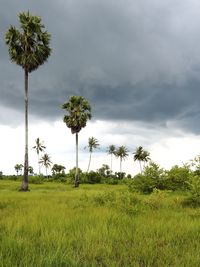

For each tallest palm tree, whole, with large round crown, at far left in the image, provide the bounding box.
[5,12,51,191]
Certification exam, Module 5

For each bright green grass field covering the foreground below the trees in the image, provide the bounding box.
[0,180,200,267]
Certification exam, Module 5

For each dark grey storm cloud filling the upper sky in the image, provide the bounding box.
[0,0,200,133]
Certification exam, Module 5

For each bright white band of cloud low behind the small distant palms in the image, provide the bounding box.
[0,121,200,174]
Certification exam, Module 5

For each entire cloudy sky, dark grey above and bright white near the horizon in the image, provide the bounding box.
[0,0,200,174]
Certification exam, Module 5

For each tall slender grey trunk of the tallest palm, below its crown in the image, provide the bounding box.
[21,69,28,191]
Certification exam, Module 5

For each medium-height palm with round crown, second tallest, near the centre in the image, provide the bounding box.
[62,96,91,187]
